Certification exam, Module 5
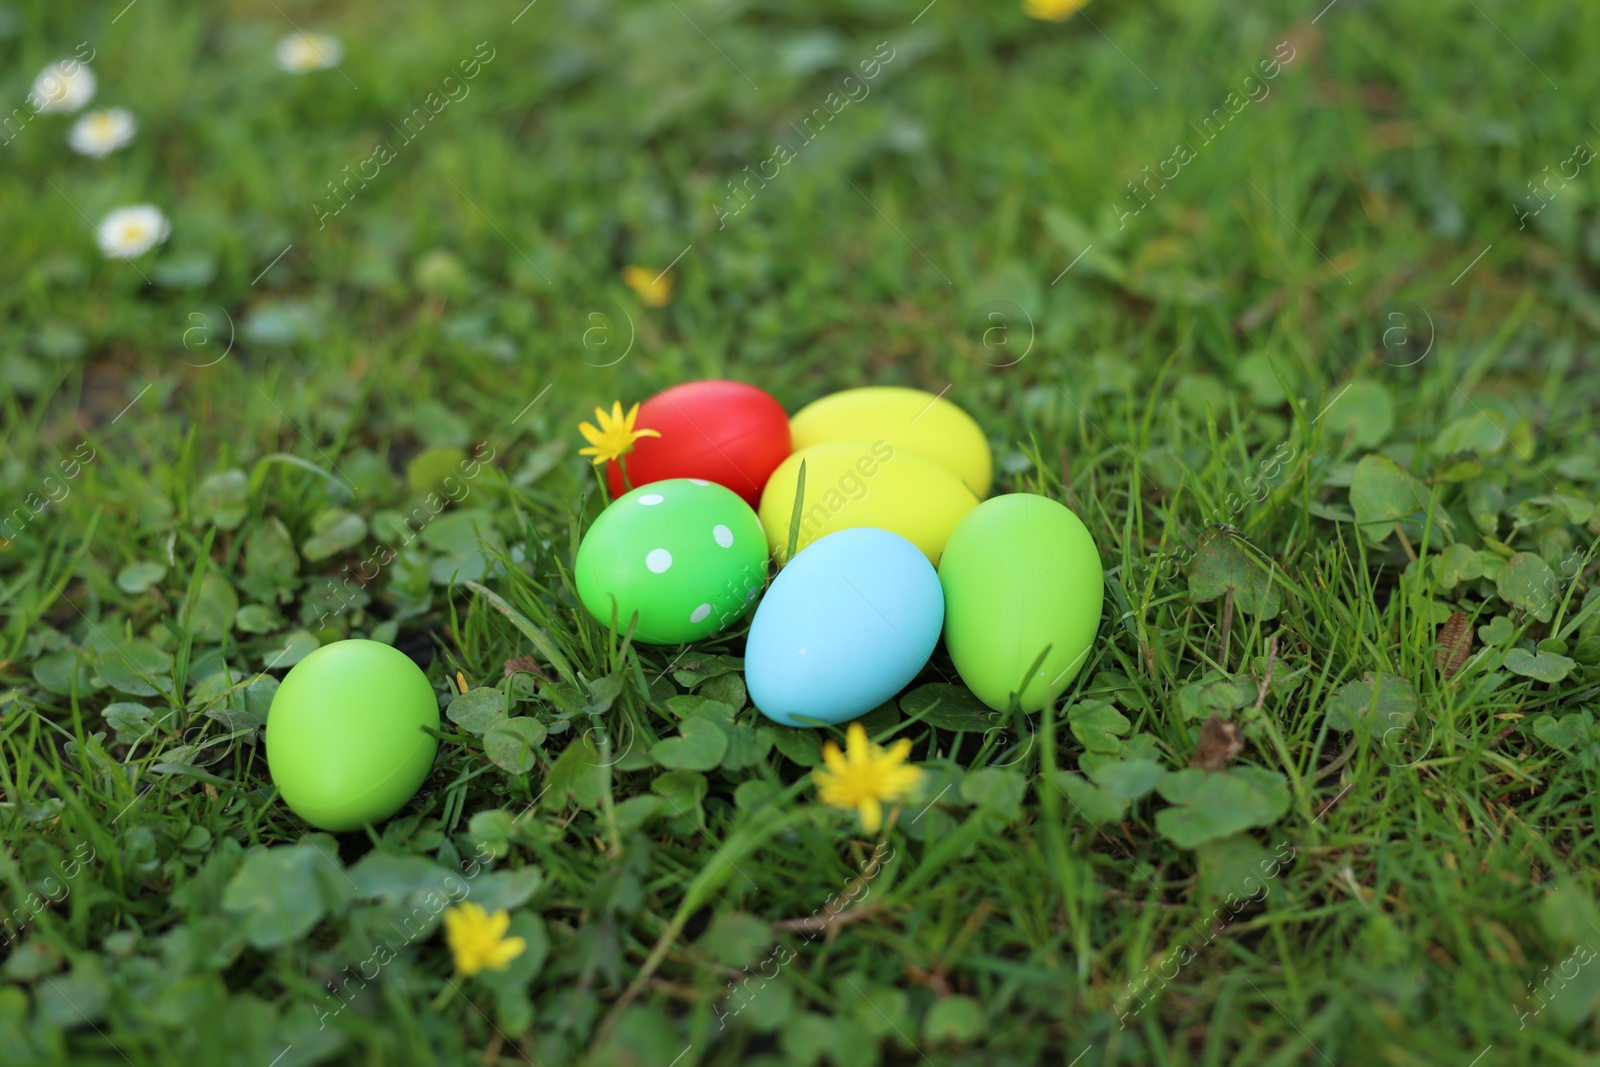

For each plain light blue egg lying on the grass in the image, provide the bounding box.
[744,526,944,726]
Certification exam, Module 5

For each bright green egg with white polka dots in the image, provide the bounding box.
[573,478,766,645]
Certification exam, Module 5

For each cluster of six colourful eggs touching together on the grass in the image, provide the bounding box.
[574,381,1104,726]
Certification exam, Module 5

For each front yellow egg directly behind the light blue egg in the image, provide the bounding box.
[760,440,978,566]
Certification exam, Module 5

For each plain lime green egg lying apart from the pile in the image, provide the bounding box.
[267,640,438,832]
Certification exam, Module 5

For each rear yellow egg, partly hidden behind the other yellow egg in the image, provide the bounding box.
[789,386,994,499]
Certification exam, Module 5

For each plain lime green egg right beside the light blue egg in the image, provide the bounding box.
[939,493,1106,712]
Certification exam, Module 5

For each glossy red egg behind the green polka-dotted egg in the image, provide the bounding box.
[606,381,794,507]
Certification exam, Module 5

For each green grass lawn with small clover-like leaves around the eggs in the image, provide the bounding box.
[0,0,1600,1067]
